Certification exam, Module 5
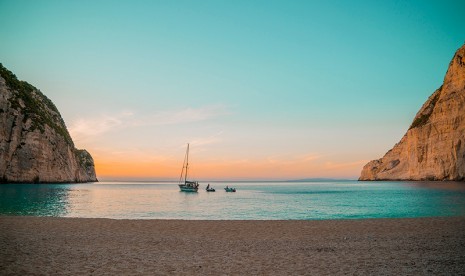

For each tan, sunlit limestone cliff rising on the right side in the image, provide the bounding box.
[359,45,465,181]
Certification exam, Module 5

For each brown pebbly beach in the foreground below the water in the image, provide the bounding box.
[0,216,465,275]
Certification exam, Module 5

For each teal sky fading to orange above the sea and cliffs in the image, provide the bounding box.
[0,0,465,180]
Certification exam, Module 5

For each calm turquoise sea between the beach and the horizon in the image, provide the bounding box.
[0,181,465,220]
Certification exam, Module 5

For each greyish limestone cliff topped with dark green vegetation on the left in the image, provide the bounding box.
[0,64,97,183]
